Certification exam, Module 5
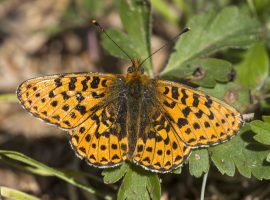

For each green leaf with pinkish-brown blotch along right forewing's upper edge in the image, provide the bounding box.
[199,83,250,111]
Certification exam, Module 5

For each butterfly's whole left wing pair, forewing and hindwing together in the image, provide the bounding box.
[17,73,127,167]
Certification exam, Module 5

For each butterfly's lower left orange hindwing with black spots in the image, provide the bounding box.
[69,97,128,167]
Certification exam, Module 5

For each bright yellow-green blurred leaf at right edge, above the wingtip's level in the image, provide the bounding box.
[236,43,269,89]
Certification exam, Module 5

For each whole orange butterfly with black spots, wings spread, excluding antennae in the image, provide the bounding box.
[17,57,243,173]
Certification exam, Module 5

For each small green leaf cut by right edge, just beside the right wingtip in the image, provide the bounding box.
[250,120,270,145]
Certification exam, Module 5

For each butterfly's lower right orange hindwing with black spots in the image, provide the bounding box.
[133,93,190,173]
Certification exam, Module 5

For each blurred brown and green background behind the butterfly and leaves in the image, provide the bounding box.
[0,0,270,200]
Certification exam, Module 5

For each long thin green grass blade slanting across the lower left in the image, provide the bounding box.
[0,150,112,200]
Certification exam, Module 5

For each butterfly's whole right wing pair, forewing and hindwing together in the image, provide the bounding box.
[133,80,243,173]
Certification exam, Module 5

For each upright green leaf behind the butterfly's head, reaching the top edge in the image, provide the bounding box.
[102,0,152,75]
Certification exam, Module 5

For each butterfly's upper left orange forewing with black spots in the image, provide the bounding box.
[17,73,122,129]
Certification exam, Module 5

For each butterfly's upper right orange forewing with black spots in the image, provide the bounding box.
[155,80,243,147]
